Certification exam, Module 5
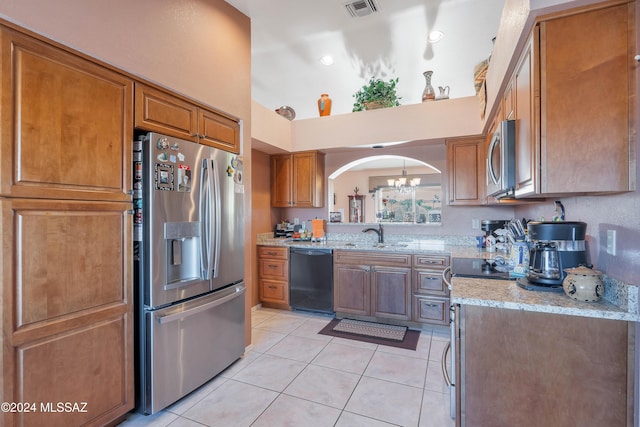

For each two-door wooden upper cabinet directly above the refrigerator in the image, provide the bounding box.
[135,82,240,153]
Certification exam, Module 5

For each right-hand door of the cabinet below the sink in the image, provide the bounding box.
[371,266,411,320]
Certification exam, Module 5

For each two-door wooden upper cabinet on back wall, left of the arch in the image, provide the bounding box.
[271,151,324,208]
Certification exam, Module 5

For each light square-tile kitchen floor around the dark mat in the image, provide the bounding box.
[121,308,454,427]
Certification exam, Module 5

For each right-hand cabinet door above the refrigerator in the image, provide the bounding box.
[198,108,240,153]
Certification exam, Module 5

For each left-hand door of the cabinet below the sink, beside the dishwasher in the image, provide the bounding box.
[333,264,371,316]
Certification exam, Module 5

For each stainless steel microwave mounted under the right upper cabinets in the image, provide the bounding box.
[487,120,516,198]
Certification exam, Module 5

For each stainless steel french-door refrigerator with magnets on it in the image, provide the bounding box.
[133,133,245,414]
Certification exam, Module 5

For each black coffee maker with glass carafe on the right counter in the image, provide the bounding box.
[527,221,587,287]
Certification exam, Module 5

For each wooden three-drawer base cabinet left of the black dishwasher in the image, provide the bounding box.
[258,246,291,310]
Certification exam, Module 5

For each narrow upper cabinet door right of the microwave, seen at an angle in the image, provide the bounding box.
[513,32,540,197]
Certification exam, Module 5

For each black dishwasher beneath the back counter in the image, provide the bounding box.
[289,248,333,313]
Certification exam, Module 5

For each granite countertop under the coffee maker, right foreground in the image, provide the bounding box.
[451,277,640,322]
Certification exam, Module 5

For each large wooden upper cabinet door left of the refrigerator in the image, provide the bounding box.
[0,29,133,201]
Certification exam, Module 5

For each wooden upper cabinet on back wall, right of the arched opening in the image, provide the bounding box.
[446,137,486,205]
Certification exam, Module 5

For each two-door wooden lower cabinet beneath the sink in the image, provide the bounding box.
[333,251,411,320]
